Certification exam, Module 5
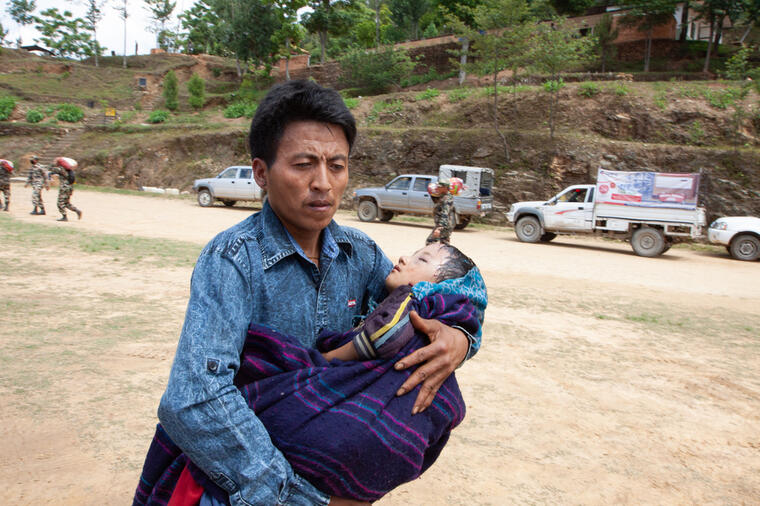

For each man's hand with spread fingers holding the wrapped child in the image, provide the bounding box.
[395,311,468,415]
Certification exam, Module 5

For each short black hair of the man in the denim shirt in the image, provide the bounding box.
[248,80,356,168]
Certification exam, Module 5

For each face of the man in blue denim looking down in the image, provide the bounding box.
[253,121,348,240]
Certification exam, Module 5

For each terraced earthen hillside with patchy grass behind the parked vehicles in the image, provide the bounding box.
[0,51,760,219]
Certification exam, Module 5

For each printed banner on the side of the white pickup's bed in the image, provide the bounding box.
[596,169,699,209]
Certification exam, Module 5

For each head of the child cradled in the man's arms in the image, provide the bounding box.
[385,242,475,292]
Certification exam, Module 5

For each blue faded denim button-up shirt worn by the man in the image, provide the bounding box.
[158,204,475,506]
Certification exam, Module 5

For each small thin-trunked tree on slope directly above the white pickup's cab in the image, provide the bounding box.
[528,18,596,139]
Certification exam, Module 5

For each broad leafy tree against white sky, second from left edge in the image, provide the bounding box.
[34,7,92,58]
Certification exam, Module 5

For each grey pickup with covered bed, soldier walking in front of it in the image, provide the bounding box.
[354,165,493,230]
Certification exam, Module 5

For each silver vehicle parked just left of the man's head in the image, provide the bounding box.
[193,165,264,207]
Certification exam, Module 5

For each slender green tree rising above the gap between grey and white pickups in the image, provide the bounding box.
[450,0,530,161]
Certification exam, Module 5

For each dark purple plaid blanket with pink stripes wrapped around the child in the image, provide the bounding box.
[134,294,480,505]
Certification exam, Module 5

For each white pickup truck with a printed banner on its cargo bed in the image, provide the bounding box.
[507,169,706,257]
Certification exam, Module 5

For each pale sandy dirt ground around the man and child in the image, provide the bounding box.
[0,184,760,506]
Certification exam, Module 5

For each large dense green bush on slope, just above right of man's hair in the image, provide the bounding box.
[339,47,416,94]
